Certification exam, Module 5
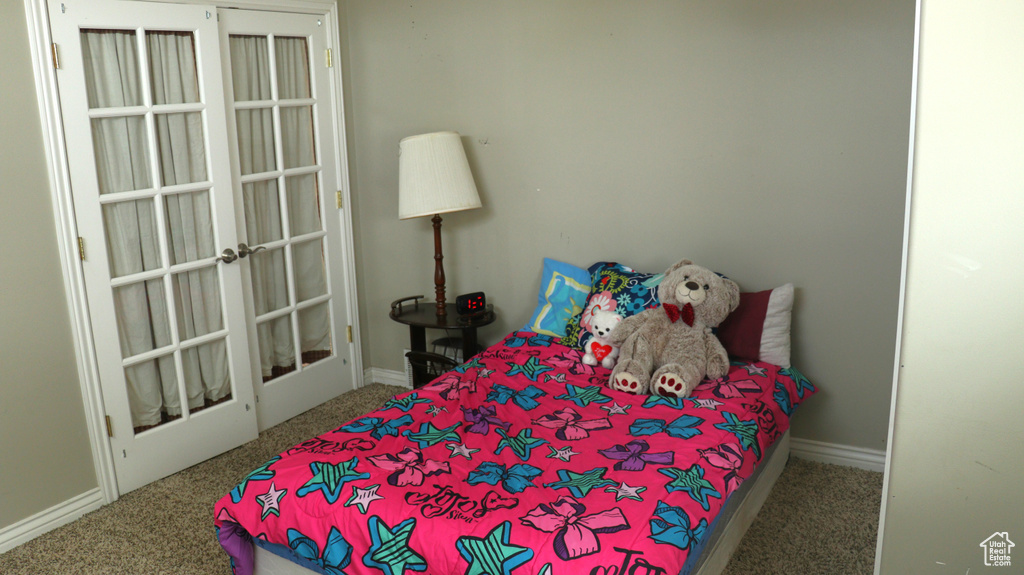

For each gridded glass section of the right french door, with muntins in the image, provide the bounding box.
[228,35,333,382]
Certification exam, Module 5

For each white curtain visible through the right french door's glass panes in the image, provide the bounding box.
[229,36,331,380]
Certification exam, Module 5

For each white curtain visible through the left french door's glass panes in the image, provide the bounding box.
[82,31,230,428]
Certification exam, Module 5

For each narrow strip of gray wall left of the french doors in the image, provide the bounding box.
[0,2,96,529]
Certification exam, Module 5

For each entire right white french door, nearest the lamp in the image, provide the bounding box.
[220,10,351,430]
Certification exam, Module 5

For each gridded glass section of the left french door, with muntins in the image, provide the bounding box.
[81,29,231,433]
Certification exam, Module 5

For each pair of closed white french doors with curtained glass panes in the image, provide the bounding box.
[49,0,353,493]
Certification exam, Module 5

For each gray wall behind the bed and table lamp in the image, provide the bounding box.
[344,0,914,449]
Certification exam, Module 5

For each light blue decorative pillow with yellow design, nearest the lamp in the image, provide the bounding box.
[524,258,590,338]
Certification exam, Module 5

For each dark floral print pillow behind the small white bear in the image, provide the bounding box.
[561,262,665,349]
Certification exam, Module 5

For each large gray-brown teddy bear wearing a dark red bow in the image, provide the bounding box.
[607,260,739,397]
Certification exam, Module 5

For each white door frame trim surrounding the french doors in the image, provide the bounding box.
[24,0,362,503]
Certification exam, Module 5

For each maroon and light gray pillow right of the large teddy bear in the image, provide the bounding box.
[718,283,794,367]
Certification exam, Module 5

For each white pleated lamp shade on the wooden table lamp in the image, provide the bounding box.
[398,132,480,220]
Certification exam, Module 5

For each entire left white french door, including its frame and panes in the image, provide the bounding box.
[50,0,255,492]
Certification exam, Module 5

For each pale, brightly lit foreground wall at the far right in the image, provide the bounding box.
[880,0,1024,573]
